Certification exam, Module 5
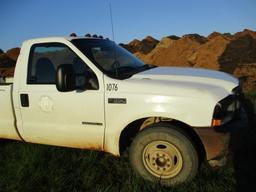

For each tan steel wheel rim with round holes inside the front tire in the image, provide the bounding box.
[142,141,183,179]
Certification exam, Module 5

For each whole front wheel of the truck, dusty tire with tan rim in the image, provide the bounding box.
[129,123,198,186]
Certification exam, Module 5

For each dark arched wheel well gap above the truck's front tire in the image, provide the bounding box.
[119,117,206,162]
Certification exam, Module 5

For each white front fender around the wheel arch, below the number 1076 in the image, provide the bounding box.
[104,93,216,155]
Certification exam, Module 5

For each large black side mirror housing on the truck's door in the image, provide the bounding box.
[56,64,76,92]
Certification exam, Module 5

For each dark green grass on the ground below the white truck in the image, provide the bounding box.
[0,141,235,192]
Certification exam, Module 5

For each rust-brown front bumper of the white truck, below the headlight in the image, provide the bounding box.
[194,109,248,166]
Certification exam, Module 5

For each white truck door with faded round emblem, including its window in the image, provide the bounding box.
[19,43,105,150]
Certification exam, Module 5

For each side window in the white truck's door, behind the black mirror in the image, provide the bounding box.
[27,43,97,87]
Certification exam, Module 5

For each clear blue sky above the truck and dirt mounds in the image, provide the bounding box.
[0,0,256,50]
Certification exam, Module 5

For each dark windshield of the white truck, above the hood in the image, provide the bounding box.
[71,39,152,79]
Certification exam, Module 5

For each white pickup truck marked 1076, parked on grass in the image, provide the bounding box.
[0,36,244,185]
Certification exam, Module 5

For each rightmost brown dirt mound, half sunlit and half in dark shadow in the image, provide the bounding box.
[190,31,256,74]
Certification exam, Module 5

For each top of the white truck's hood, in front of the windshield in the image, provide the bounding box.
[132,67,239,92]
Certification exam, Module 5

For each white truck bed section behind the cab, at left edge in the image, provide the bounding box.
[0,82,20,140]
